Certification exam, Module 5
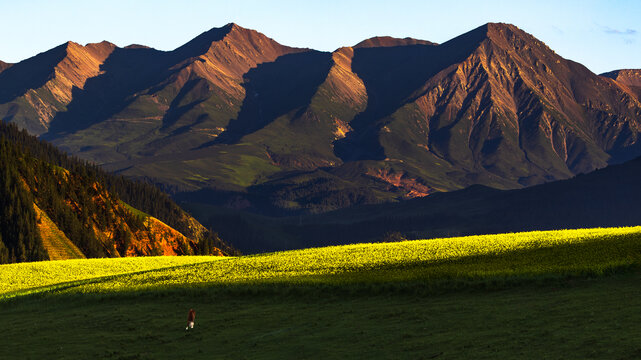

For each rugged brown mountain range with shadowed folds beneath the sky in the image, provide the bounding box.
[0,24,641,214]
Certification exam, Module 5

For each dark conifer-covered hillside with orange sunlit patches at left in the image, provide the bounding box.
[0,124,233,263]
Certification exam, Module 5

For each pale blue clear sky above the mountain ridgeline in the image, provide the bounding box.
[0,0,641,73]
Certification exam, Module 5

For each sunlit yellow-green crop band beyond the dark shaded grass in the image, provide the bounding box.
[0,227,641,298]
